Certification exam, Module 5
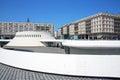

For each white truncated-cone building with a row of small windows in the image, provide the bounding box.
[5,31,55,47]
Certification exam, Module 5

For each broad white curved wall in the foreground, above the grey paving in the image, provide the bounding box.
[0,48,120,77]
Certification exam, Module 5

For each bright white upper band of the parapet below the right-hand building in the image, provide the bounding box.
[62,40,120,48]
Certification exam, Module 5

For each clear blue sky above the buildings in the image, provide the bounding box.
[0,0,120,30]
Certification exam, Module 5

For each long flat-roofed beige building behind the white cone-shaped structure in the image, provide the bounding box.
[0,20,54,39]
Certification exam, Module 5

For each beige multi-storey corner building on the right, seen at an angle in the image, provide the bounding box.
[58,12,120,40]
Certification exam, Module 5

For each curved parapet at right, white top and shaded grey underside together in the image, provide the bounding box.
[62,40,120,55]
